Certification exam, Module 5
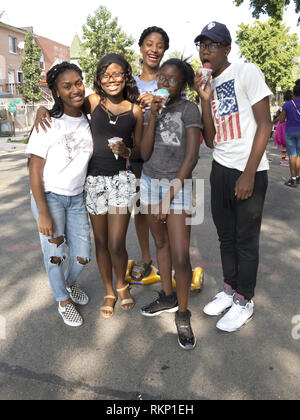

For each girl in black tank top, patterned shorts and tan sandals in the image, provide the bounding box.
[85,54,143,318]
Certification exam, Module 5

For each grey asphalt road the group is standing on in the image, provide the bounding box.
[0,139,300,401]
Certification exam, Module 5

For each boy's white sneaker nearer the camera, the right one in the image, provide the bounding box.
[217,300,254,332]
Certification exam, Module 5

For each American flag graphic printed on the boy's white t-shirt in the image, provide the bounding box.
[212,80,242,143]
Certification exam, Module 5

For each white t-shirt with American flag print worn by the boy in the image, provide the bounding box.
[211,63,272,172]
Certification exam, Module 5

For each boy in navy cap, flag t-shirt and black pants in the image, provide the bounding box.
[195,22,272,332]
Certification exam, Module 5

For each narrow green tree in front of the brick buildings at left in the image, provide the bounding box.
[19,32,43,103]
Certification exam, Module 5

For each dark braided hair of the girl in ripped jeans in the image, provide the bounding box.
[47,61,83,118]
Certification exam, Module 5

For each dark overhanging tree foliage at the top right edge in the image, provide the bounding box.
[234,0,300,25]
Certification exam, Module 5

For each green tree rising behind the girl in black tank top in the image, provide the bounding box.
[79,6,138,87]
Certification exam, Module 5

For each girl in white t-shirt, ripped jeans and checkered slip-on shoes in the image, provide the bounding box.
[26,62,93,327]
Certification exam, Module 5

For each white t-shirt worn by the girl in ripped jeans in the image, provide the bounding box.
[26,114,93,197]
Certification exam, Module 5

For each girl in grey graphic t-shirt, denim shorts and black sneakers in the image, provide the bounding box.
[141,59,201,350]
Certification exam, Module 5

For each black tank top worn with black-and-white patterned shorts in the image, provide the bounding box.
[88,104,136,176]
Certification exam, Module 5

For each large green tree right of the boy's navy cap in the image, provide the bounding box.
[237,19,300,93]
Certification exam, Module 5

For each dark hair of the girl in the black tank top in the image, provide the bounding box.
[94,54,140,103]
